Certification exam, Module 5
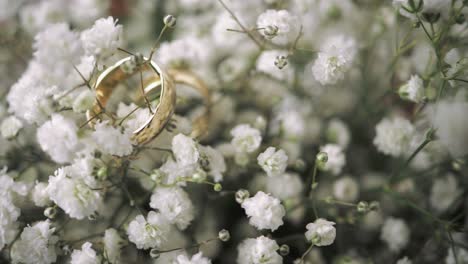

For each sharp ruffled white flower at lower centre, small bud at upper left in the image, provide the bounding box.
[241,192,286,231]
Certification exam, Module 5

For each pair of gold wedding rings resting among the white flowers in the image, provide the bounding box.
[87,56,211,145]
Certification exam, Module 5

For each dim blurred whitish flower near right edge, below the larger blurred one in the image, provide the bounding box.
[430,174,460,212]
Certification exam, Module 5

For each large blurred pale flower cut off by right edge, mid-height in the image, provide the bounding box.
[426,101,468,157]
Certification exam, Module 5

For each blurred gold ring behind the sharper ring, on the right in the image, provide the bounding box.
[145,69,212,139]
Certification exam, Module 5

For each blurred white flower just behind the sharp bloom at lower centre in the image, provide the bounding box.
[266,173,304,200]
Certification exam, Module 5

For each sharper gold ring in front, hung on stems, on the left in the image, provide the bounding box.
[86,56,176,144]
